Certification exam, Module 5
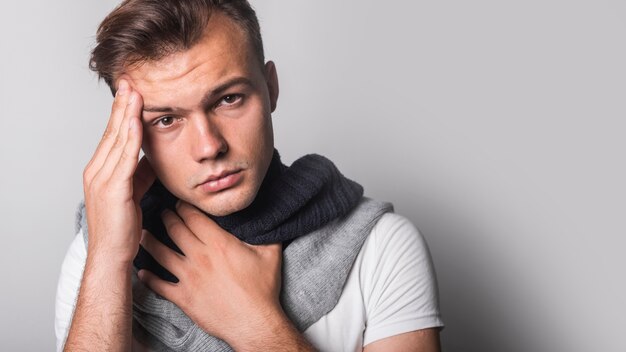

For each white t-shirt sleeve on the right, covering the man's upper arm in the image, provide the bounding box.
[360,213,443,346]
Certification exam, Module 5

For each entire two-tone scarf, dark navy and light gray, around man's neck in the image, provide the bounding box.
[77,153,393,351]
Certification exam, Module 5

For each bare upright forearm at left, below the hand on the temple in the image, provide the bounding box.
[65,255,132,351]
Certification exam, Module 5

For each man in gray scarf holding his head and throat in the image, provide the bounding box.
[55,0,442,352]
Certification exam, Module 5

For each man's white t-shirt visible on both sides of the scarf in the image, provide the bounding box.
[54,213,443,351]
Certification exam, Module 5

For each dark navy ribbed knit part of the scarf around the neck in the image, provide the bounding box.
[134,150,363,282]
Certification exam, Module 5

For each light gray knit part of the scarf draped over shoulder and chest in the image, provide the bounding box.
[77,197,393,351]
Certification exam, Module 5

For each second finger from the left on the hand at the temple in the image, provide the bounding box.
[99,92,141,181]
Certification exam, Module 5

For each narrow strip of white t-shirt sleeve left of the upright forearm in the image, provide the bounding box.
[54,231,87,351]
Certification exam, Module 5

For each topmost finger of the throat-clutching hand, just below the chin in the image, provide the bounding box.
[176,200,230,244]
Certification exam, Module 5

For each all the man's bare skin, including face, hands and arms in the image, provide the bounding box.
[65,14,439,352]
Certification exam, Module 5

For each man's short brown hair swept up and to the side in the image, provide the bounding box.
[89,0,265,92]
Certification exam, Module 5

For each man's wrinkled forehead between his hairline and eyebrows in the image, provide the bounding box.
[116,13,258,94]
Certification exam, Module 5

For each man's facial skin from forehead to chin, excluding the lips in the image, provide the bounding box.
[130,16,278,215]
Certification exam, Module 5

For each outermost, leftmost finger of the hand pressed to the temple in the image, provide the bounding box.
[87,79,130,177]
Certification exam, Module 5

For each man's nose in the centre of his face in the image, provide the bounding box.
[190,116,228,162]
